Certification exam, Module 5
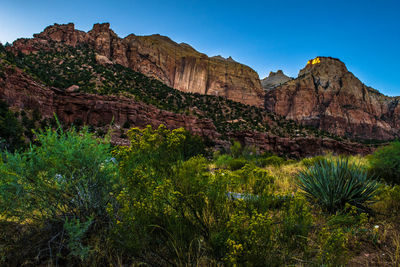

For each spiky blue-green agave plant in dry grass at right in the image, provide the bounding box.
[297,158,379,212]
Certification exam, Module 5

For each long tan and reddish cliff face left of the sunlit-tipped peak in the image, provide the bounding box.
[13,23,264,107]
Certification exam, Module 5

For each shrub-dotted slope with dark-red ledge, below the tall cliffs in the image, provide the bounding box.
[0,34,373,158]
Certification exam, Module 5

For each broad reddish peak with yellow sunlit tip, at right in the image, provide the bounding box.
[265,57,400,140]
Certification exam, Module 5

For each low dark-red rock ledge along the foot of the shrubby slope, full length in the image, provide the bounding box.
[0,62,372,157]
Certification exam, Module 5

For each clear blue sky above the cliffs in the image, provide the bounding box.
[0,0,400,95]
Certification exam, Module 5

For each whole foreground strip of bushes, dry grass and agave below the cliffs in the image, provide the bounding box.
[0,124,400,266]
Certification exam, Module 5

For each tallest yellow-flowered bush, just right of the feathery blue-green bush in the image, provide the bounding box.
[109,126,227,265]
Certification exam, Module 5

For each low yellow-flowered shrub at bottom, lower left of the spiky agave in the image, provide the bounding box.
[224,199,311,266]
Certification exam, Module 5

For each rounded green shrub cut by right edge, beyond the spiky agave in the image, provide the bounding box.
[368,141,400,184]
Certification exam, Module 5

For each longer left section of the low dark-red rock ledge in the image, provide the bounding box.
[0,63,220,140]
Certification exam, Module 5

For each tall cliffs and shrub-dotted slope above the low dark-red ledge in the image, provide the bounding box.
[1,23,400,154]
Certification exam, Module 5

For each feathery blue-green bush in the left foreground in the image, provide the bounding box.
[0,126,118,265]
